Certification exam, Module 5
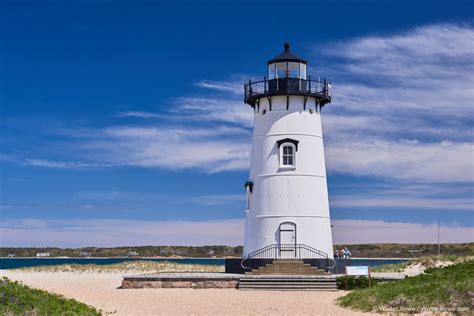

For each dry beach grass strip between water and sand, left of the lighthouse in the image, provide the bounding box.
[17,260,224,273]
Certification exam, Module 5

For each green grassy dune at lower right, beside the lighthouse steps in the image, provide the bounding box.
[338,260,474,313]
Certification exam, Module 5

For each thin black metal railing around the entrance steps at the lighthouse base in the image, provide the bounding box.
[241,244,336,271]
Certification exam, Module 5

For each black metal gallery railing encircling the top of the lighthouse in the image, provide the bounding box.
[244,76,332,105]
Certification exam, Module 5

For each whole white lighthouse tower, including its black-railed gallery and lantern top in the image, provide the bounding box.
[244,43,333,259]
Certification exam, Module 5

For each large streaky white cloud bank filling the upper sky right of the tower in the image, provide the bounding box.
[314,25,474,182]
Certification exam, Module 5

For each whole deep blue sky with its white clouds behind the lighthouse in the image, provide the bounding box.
[0,0,474,246]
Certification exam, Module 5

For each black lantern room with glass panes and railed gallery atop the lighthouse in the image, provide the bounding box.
[244,43,331,108]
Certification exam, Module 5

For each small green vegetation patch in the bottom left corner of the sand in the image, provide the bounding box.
[0,278,100,315]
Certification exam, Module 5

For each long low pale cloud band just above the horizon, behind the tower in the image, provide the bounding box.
[0,219,474,247]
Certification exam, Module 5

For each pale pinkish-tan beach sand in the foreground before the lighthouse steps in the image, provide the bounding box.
[0,270,367,315]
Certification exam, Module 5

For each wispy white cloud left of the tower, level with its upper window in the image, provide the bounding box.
[81,126,249,172]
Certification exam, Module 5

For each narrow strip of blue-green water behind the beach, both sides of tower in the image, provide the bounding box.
[0,258,408,269]
